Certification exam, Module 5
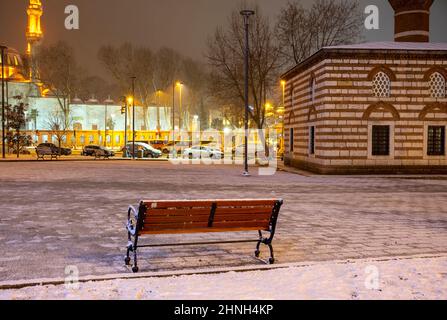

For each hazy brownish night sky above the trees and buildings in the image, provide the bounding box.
[0,0,447,74]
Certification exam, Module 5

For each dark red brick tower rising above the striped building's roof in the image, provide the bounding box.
[389,0,434,42]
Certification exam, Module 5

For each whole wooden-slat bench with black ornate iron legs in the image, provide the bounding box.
[125,199,283,272]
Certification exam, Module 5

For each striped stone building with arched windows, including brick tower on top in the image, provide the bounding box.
[282,0,447,174]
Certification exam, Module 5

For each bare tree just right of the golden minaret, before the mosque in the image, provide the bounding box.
[36,42,80,127]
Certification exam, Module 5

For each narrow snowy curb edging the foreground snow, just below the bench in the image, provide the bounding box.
[0,253,447,290]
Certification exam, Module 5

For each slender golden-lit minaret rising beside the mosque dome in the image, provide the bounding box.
[26,0,43,80]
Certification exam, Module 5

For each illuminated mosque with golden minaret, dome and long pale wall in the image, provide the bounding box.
[0,0,171,148]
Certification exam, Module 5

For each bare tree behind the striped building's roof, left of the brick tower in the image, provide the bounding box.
[276,0,362,66]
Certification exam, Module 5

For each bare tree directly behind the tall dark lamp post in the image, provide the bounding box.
[206,8,280,129]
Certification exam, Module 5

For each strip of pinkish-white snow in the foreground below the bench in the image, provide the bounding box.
[0,256,447,300]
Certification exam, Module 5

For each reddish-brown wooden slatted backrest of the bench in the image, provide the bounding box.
[137,199,282,234]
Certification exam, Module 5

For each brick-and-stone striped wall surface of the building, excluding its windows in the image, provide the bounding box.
[285,55,447,173]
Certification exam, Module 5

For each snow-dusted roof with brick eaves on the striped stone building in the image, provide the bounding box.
[281,41,447,79]
